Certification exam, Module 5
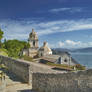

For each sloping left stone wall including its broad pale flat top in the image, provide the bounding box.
[0,56,62,84]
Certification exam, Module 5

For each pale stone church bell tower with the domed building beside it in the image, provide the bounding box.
[23,29,52,58]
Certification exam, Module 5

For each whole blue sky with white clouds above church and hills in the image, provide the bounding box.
[0,0,92,48]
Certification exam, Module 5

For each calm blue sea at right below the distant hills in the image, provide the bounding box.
[70,52,92,68]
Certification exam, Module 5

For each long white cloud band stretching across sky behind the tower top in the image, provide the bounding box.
[0,18,92,40]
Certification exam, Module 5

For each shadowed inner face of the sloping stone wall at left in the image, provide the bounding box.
[0,56,30,82]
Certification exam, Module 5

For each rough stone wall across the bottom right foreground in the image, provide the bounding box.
[32,69,92,92]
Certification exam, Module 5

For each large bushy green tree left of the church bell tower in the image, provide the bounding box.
[4,40,30,58]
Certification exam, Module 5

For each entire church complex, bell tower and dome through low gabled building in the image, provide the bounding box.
[22,29,79,65]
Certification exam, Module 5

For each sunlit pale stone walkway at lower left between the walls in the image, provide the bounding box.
[2,70,33,92]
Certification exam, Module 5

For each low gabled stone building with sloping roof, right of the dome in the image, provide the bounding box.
[40,52,79,66]
